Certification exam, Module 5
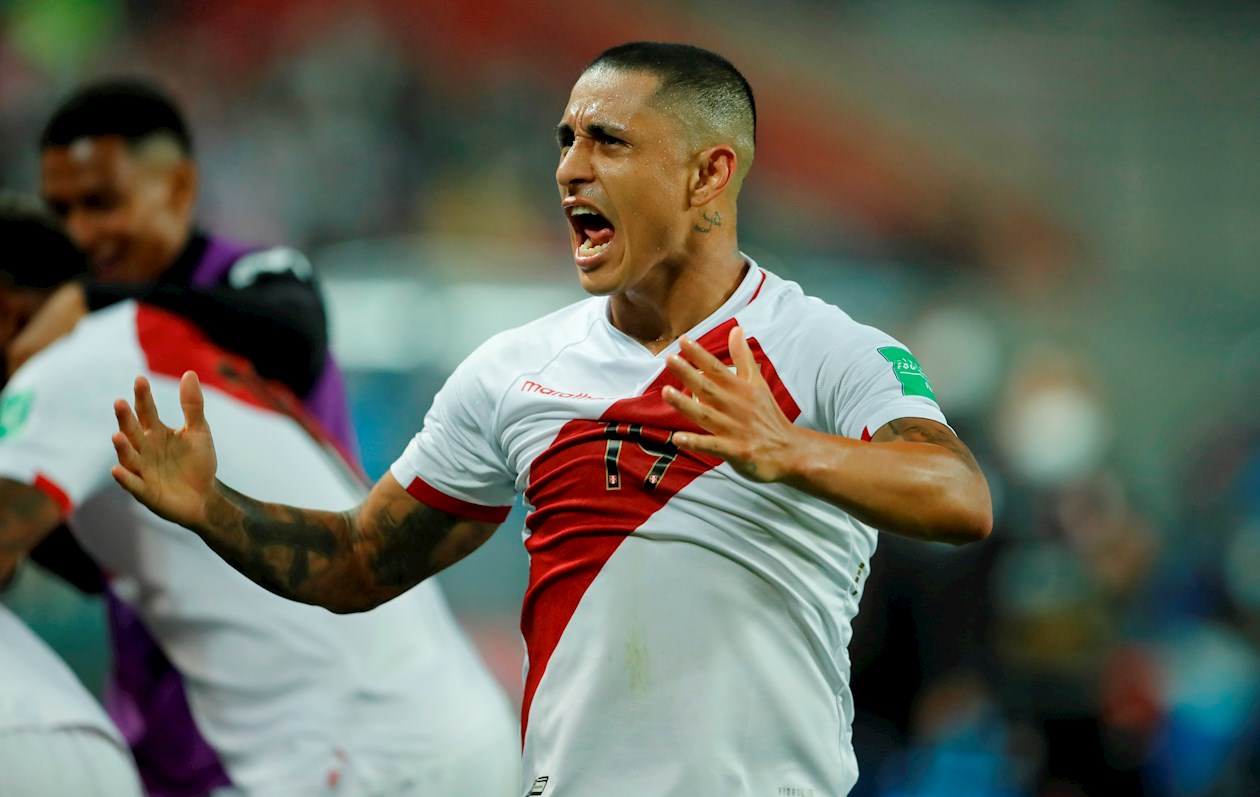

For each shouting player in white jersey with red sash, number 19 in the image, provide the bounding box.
[113,43,992,797]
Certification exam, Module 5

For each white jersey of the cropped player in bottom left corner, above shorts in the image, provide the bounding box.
[0,604,126,749]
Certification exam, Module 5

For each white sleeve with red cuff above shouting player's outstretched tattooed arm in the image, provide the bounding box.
[389,342,517,523]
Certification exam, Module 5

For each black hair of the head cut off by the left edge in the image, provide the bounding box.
[0,191,88,290]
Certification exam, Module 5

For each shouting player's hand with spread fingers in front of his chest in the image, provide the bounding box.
[663,326,798,481]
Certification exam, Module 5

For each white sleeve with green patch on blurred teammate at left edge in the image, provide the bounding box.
[0,335,120,515]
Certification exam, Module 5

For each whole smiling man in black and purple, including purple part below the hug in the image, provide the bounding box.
[24,79,357,797]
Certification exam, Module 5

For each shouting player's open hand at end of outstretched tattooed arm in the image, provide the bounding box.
[110,371,218,528]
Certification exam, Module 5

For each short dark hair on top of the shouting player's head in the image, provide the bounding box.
[583,42,757,145]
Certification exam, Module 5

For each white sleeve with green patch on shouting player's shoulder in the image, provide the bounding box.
[819,327,948,439]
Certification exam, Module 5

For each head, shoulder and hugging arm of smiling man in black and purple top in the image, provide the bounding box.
[29,78,354,451]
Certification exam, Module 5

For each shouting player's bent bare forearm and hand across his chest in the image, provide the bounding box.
[663,327,993,544]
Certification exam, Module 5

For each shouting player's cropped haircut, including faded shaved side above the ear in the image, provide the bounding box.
[583,42,757,180]
